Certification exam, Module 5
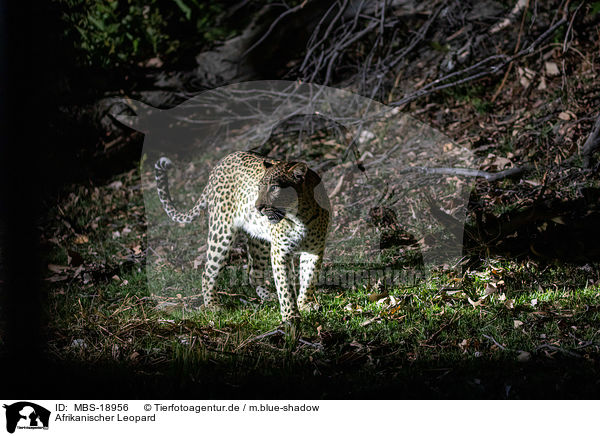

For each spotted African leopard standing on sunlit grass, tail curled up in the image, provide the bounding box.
[155,151,331,323]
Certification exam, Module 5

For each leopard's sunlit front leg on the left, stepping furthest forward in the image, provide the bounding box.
[271,239,300,322]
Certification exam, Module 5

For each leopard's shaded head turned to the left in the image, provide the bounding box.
[255,161,308,224]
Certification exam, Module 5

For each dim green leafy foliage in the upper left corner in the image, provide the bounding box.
[56,0,229,67]
